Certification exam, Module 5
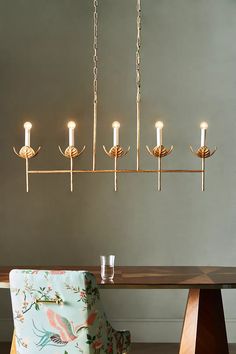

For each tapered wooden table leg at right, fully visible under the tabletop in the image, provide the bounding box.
[179,289,229,354]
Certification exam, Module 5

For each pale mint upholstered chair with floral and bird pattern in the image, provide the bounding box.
[10,269,130,354]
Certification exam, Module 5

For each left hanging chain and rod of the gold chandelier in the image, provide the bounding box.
[93,0,98,171]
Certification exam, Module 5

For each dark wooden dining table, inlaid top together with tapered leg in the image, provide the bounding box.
[0,266,236,354]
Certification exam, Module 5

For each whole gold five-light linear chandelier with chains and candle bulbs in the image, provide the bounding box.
[13,0,216,192]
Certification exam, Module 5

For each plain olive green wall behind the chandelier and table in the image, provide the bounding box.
[0,0,236,341]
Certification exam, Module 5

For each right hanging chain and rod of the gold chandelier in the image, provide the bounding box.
[136,0,141,170]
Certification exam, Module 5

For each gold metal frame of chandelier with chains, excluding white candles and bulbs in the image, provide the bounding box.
[13,0,216,192]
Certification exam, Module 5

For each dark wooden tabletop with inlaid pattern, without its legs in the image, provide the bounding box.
[0,265,236,289]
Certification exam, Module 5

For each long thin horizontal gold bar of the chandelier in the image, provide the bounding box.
[28,170,204,174]
